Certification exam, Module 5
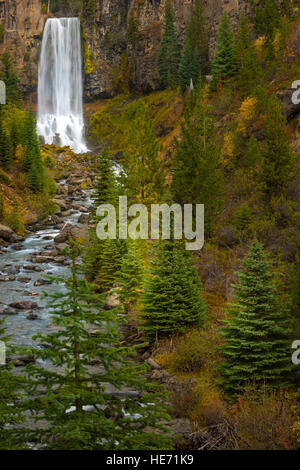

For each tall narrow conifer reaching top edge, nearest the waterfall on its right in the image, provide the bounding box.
[158,0,180,88]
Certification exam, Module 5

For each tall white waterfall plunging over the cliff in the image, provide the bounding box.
[37,18,88,153]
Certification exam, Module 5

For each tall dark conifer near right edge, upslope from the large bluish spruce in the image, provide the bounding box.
[260,96,293,200]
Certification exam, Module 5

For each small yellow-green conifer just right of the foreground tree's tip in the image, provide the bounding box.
[118,241,143,313]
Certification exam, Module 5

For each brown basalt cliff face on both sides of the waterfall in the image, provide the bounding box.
[0,0,248,100]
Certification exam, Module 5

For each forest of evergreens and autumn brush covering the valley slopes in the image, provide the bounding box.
[0,0,300,450]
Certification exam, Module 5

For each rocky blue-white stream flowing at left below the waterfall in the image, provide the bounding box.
[0,190,91,346]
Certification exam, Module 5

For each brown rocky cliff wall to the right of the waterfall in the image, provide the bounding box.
[85,0,248,99]
